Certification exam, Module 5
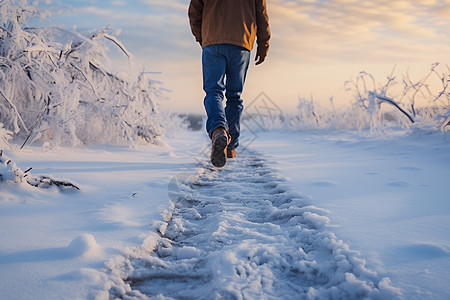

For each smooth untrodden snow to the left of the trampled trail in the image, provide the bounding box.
[0,142,198,300]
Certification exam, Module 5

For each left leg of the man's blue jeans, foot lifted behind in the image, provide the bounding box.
[202,45,229,137]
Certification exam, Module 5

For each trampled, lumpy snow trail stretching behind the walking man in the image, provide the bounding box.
[105,152,401,299]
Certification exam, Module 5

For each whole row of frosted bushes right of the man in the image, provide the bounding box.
[291,63,450,133]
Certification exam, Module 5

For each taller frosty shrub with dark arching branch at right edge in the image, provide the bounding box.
[347,63,450,130]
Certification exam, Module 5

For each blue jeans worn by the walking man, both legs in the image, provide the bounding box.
[202,44,250,149]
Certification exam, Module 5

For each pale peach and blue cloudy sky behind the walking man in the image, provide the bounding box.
[34,0,450,112]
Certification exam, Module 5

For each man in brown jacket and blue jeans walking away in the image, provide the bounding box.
[189,0,270,167]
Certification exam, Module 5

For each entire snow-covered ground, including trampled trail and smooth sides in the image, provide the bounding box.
[0,130,450,300]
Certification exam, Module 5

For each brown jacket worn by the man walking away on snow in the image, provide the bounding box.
[189,0,270,57]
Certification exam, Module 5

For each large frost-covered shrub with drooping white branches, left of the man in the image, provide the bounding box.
[0,0,169,146]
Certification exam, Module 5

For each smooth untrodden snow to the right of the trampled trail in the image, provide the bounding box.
[252,130,450,300]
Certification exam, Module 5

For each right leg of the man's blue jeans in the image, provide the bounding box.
[225,45,250,149]
